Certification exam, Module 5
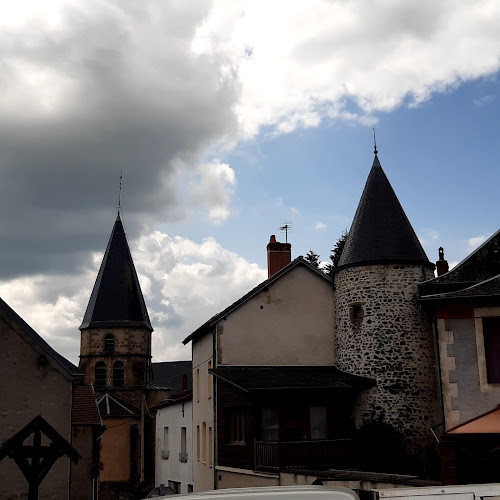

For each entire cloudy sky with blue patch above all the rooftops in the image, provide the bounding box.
[0,0,500,364]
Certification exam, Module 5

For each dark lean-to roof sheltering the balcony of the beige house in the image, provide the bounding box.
[209,366,376,391]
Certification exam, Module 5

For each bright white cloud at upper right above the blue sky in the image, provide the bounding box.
[193,0,500,137]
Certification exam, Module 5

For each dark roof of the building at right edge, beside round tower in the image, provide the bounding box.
[419,230,500,297]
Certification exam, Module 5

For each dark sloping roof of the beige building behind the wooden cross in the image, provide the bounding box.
[0,299,83,379]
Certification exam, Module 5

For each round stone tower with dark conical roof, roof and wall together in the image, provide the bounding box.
[334,150,439,452]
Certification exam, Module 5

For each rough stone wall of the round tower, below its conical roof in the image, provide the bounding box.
[335,265,439,451]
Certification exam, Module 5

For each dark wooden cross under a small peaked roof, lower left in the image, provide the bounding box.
[0,415,80,500]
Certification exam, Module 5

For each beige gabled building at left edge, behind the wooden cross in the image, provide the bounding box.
[0,299,101,500]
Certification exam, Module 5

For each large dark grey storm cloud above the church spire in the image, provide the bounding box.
[0,2,238,277]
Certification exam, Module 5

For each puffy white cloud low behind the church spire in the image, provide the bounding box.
[0,231,267,364]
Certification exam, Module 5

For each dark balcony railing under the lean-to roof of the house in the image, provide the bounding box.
[255,439,351,470]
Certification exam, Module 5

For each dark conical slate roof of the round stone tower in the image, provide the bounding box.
[337,155,432,269]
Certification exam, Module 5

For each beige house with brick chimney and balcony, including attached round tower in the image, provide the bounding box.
[184,152,441,491]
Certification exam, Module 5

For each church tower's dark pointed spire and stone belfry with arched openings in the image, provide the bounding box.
[80,212,153,396]
